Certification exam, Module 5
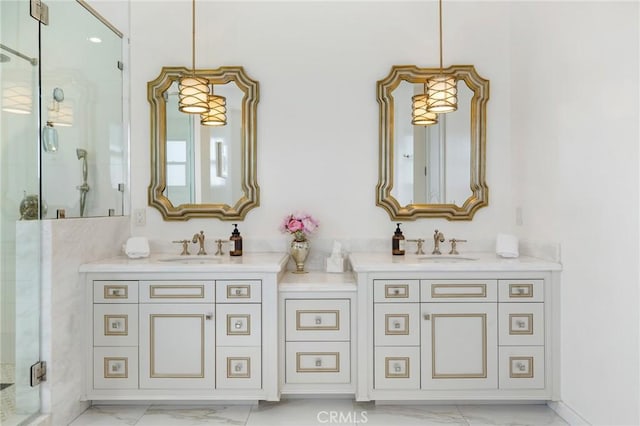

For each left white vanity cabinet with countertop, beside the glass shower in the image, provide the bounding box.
[81,253,287,401]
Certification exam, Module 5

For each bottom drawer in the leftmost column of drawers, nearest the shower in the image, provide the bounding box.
[93,347,138,389]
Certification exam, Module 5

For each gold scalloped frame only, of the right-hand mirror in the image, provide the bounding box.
[376,65,489,220]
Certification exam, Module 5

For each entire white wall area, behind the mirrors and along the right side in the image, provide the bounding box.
[90,0,640,424]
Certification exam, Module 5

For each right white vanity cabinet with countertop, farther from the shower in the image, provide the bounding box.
[350,253,560,401]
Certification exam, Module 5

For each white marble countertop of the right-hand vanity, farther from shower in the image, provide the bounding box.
[349,252,562,272]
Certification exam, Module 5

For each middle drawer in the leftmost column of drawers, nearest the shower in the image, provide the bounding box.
[93,304,138,346]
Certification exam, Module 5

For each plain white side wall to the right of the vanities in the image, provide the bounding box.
[511,2,640,425]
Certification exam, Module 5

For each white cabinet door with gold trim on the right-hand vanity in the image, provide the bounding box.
[421,303,498,389]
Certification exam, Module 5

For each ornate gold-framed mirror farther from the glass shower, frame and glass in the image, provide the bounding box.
[376,65,489,220]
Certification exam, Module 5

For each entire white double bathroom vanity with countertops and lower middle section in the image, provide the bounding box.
[81,253,560,401]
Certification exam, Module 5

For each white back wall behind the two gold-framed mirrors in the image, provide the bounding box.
[131,0,512,243]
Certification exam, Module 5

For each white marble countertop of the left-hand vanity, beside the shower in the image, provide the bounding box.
[79,252,289,273]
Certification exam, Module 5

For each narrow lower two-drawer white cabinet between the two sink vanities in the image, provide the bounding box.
[279,272,356,394]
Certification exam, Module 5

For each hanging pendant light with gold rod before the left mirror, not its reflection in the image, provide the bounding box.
[178,0,209,114]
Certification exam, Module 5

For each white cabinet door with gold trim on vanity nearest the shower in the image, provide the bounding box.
[140,304,215,389]
